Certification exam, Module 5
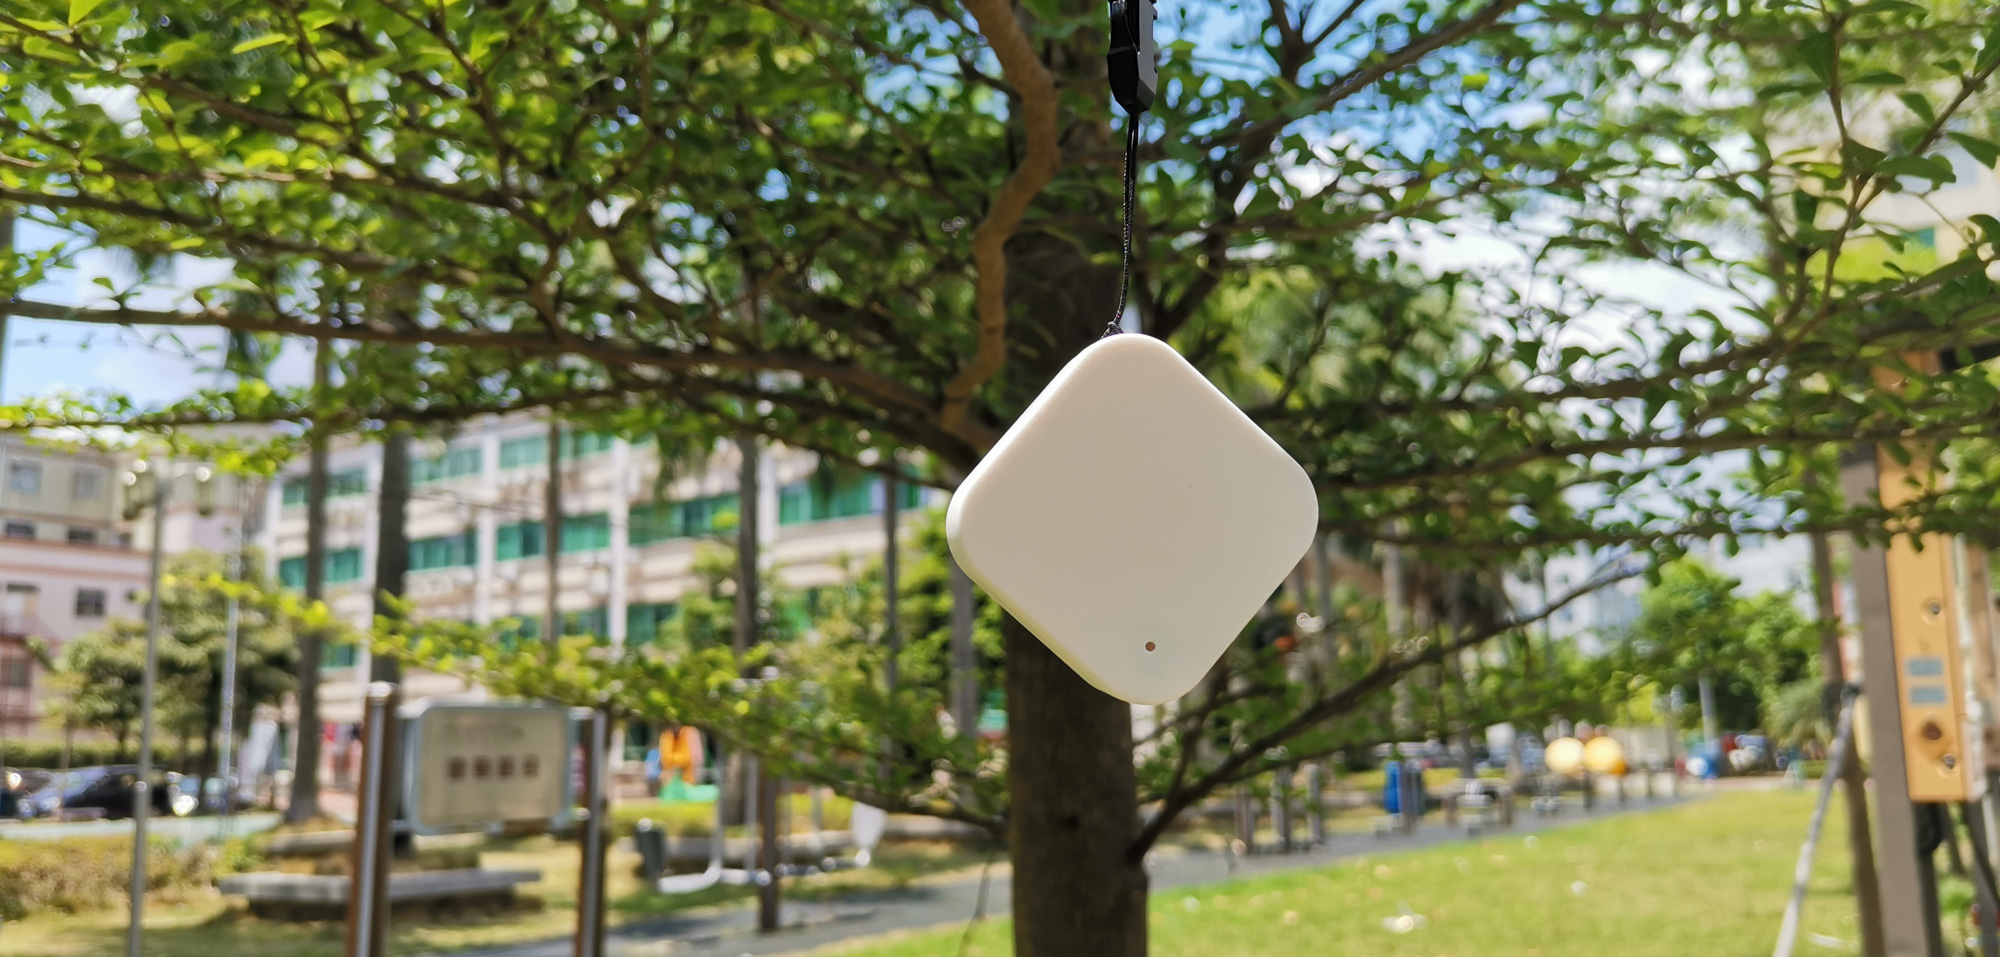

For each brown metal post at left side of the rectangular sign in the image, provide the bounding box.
[346,681,402,957]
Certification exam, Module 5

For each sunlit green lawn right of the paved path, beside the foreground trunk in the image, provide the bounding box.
[822,791,1856,957]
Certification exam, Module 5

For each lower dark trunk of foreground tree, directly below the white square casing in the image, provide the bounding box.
[1000,615,1146,957]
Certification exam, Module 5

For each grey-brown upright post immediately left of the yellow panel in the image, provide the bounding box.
[1840,446,1944,957]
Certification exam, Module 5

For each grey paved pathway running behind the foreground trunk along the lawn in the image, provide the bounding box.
[460,791,1704,957]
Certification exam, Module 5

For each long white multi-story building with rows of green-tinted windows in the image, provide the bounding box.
[262,416,932,725]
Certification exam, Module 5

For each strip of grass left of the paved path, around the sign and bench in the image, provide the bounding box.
[0,837,986,957]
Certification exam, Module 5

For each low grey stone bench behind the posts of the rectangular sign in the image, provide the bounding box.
[216,867,542,921]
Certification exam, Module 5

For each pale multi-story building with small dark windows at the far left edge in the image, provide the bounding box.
[0,434,146,737]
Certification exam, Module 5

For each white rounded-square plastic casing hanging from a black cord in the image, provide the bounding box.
[944,334,1320,705]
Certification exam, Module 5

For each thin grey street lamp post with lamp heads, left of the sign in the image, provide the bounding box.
[124,458,214,957]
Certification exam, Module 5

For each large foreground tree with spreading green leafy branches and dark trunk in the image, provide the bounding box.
[0,0,2000,953]
